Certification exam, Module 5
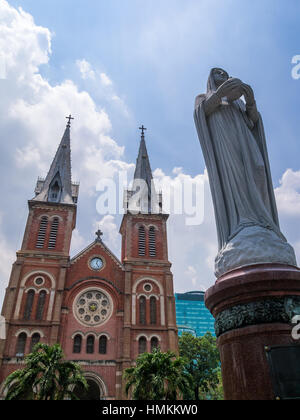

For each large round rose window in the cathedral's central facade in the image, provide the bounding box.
[74,290,112,325]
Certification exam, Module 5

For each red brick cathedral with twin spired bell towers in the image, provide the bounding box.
[0,120,178,400]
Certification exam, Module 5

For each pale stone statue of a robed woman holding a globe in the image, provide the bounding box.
[194,68,297,277]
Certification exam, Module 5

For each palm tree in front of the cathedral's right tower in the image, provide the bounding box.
[124,349,191,401]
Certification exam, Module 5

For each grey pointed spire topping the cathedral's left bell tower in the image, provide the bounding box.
[34,115,74,204]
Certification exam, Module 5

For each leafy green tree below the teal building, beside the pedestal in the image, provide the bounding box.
[179,332,223,400]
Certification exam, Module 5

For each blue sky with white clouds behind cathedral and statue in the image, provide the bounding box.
[0,0,300,306]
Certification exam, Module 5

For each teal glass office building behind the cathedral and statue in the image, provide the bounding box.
[175,292,215,337]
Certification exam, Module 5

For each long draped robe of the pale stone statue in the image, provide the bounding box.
[194,69,286,251]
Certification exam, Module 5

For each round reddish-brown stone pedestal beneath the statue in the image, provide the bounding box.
[205,264,300,400]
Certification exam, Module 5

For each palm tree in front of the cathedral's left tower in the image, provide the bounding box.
[4,343,88,400]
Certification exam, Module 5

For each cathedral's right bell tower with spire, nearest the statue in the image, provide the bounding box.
[120,126,178,398]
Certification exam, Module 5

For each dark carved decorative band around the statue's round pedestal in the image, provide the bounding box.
[215,296,300,337]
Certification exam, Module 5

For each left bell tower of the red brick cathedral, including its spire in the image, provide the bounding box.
[0,116,79,374]
